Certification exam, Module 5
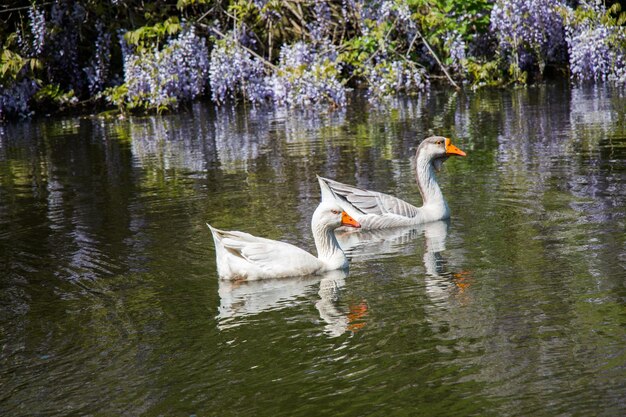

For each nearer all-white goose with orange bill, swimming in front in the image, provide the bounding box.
[207,202,361,280]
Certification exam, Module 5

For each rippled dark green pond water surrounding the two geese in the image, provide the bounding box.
[0,84,626,416]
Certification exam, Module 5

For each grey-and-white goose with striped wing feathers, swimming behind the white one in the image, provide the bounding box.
[318,136,465,230]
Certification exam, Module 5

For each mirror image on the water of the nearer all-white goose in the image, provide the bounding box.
[217,270,356,337]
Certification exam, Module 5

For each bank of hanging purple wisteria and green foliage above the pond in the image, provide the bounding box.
[0,0,626,122]
